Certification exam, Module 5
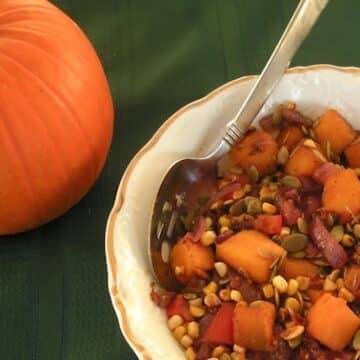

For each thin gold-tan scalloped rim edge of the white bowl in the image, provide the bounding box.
[105,64,360,360]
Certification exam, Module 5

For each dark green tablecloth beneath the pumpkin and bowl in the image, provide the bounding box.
[0,0,360,360]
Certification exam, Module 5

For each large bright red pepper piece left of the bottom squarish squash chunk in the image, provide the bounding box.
[201,302,235,345]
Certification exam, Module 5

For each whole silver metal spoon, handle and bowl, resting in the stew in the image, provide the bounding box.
[148,0,328,290]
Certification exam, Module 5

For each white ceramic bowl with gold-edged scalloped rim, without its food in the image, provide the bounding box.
[106,65,360,360]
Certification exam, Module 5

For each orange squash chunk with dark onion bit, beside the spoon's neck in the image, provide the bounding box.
[230,130,278,175]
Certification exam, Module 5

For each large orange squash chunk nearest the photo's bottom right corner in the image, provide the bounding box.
[306,293,360,351]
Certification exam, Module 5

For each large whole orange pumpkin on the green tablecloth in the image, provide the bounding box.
[0,0,114,235]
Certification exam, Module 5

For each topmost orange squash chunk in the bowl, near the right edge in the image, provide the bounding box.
[314,109,356,154]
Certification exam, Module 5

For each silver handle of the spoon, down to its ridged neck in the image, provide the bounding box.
[223,0,328,147]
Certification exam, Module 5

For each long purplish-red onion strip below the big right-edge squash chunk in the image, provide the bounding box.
[310,216,348,269]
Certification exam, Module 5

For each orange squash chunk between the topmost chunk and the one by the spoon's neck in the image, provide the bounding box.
[285,142,326,176]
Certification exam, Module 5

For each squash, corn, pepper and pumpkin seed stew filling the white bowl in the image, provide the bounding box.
[151,103,360,360]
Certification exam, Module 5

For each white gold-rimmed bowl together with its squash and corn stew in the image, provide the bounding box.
[106,65,360,360]
